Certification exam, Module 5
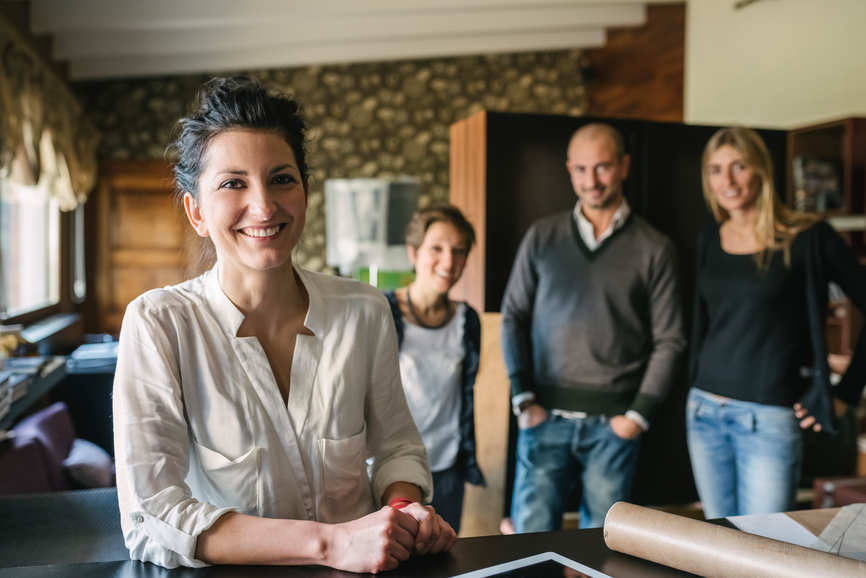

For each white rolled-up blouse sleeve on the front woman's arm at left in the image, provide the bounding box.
[113,298,235,568]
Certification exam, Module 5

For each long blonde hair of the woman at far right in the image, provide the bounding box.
[701,126,820,270]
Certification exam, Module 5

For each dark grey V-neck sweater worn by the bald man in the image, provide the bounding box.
[502,211,686,421]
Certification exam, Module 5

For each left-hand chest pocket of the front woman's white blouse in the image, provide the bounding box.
[193,442,261,516]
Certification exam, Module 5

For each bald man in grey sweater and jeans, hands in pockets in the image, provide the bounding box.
[502,124,686,532]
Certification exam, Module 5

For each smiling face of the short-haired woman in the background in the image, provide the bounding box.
[409,221,469,295]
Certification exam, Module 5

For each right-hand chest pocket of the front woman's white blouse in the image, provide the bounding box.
[319,423,367,500]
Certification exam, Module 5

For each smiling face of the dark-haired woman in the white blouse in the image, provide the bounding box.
[184,130,308,270]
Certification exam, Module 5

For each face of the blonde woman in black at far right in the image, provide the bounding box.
[706,145,761,213]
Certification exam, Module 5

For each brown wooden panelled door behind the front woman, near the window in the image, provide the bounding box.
[89,161,191,335]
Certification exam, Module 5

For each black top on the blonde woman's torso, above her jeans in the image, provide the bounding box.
[692,227,813,407]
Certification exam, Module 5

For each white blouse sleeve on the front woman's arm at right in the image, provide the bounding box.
[365,307,433,504]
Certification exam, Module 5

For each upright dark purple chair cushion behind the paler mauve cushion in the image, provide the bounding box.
[13,401,75,491]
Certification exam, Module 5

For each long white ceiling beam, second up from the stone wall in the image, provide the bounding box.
[53,4,645,60]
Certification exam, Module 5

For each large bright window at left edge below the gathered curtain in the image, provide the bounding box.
[0,179,60,319]
